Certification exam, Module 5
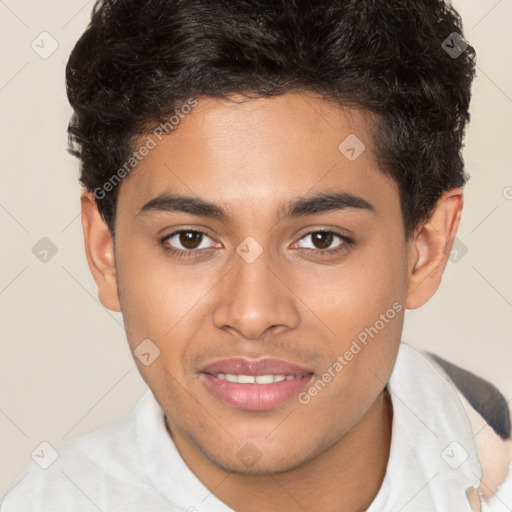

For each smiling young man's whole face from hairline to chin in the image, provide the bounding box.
[111,93,408,473]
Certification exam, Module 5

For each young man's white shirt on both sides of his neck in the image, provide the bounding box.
[0,343,512,512]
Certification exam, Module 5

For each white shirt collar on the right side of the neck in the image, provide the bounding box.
[367,343,482,512]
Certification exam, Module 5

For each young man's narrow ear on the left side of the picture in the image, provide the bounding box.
[80,192,121,312]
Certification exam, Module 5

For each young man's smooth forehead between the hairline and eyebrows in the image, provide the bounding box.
[119,93,397,219]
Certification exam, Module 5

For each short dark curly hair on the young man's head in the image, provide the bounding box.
[66,0,475,238]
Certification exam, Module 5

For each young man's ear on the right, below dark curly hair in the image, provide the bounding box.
[405,188,464,309]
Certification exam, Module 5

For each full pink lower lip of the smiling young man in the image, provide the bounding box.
[200,373,313,411]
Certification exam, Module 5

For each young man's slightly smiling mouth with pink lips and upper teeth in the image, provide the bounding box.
[199,358,314,411]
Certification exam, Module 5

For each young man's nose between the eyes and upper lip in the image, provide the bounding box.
[213,244,300,340]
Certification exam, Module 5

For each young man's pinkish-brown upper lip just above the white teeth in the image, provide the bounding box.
[200,357,313,376]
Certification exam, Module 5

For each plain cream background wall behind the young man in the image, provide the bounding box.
[0,0,512,496]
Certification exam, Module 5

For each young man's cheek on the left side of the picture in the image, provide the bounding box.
[117,236,222,387]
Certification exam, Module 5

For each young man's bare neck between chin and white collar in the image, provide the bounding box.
[168,391,393,512]
